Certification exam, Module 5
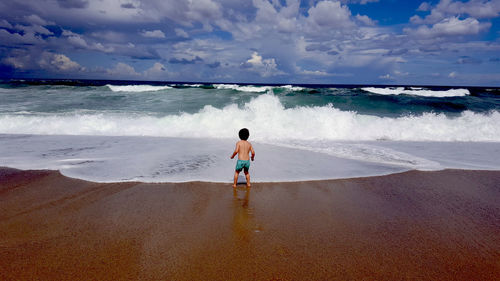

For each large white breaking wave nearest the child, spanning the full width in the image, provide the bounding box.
[0,94,500,143]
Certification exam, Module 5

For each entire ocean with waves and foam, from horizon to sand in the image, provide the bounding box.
[0,80,500,182]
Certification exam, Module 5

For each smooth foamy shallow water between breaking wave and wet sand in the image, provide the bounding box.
[0,135,500,182]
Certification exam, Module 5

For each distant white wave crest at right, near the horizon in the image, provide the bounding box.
[361,87,470,98]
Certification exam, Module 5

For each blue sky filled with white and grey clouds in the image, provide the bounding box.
[0,0,500,86]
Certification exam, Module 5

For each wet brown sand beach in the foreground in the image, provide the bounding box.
[0,168,500,280]
